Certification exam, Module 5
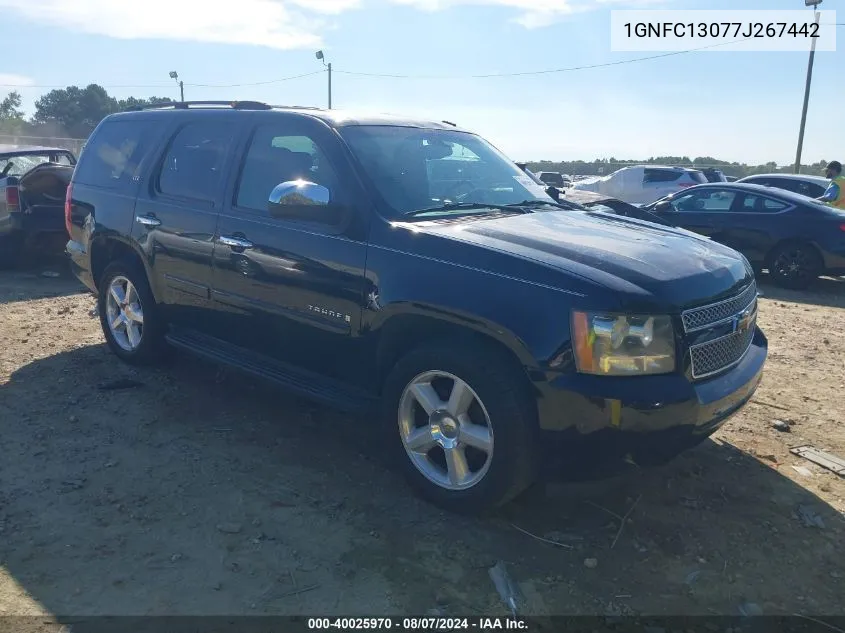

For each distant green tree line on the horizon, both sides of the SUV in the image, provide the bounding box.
[0,84,827,178]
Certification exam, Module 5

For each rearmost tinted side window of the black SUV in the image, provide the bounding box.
[74,121,154,189]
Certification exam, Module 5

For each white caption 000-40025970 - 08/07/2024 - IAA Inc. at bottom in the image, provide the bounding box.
[308,616,528,631]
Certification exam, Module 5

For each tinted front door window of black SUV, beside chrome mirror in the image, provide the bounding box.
[235,123,340,213]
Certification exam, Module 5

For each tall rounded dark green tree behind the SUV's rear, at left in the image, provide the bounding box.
[33,84,118,138]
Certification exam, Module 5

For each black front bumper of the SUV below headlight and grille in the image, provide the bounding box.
[538,328,768,478]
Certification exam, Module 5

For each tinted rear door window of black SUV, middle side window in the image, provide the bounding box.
[158,120,234,202]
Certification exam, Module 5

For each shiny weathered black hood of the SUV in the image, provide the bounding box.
[417,211,753,308]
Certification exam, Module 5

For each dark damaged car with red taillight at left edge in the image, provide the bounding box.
[0,145,76,266]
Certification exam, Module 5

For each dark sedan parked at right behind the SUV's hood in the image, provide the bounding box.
[643,182,845,289]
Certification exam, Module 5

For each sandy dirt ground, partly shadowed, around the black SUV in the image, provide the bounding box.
[0,258,845,616]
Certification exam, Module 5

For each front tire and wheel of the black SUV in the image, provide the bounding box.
[382,343,538,514]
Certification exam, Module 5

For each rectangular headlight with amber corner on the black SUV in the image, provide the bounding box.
[572,312,675,376]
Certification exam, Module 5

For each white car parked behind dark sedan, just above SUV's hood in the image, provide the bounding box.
[572,165,707,204]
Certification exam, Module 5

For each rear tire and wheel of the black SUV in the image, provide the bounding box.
[97,260,167,365]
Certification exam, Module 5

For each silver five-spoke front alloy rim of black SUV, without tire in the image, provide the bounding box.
[399,370,493,490]
